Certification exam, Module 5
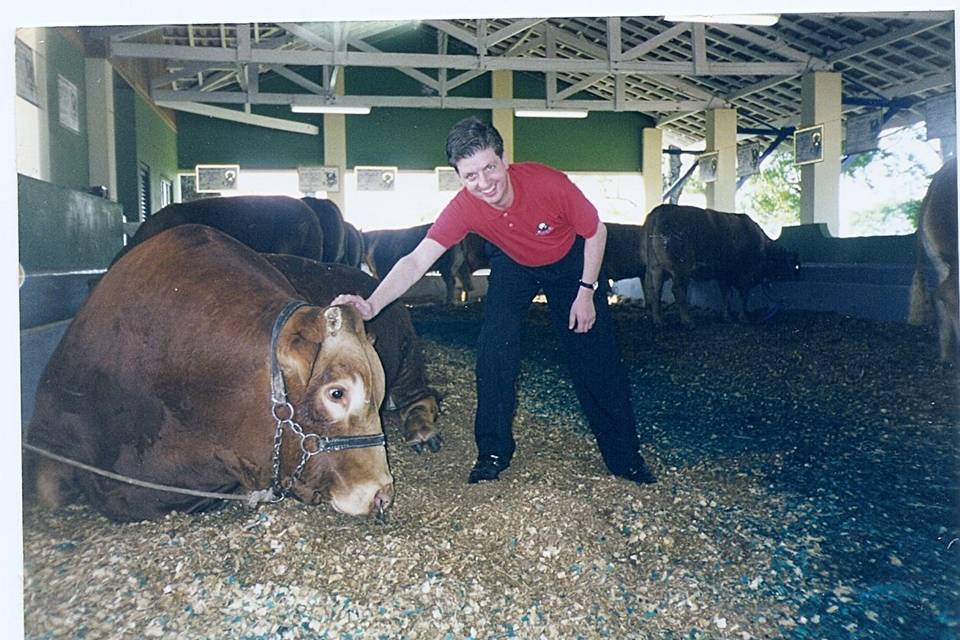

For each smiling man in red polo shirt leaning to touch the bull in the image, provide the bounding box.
[333,118,656,484]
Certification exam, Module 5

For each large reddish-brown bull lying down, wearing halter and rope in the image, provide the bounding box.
[27,225,393,520]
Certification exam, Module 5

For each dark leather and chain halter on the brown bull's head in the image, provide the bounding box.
[270,300,386,500]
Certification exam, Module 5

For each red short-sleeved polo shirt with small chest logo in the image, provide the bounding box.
[427,162,600,267]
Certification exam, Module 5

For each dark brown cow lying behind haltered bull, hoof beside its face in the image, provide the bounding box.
[264,255,441,453]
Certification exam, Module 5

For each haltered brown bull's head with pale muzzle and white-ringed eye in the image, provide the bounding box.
[277,306,393,515]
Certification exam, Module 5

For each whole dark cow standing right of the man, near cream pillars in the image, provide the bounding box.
[641,204,800,324]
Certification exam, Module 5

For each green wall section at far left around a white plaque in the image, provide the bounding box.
[45,29,90,191]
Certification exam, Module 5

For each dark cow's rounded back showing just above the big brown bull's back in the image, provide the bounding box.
[114,196,324,262]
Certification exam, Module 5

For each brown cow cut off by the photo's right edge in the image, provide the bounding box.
[909,158,960,363]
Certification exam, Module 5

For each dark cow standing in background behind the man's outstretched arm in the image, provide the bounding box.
[363,224,469,304]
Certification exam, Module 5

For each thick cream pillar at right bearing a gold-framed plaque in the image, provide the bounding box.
[800,71,843,236]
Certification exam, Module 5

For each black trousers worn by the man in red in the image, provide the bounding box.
[474,237,640,474]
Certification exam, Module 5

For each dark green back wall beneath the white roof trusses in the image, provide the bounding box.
[177,59,652,171]
